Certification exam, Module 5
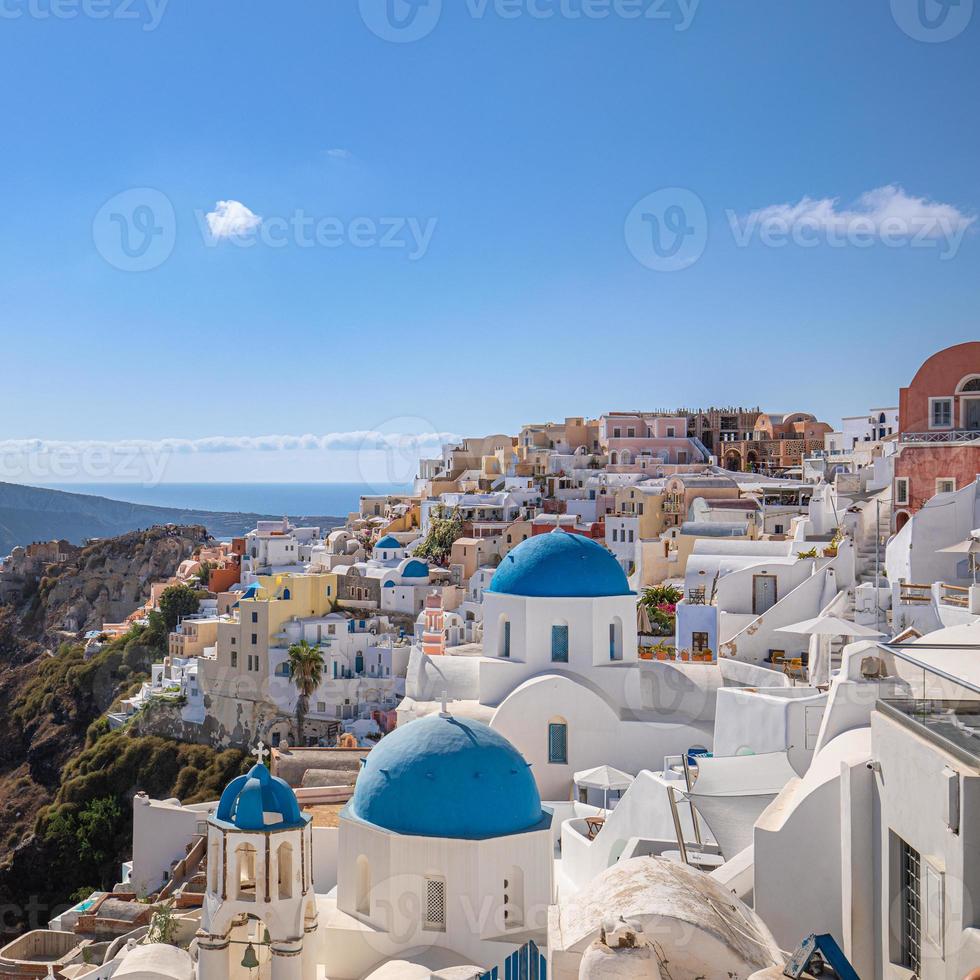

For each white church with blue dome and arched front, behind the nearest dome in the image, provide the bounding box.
[398,530,722,800]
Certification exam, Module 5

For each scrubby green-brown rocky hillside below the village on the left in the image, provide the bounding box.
[0,528,245,933]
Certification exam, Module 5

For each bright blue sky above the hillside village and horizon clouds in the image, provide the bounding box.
[0,0,980,482]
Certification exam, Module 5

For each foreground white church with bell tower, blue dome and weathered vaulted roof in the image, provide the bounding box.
[101,711,779,980]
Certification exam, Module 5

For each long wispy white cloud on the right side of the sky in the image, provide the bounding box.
[745,184,976,240]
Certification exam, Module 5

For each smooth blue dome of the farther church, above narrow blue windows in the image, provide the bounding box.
[489,531,631,598]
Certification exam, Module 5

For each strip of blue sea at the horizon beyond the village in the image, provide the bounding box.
[37,483,412,517]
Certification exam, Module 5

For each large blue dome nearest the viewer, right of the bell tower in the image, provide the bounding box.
[349,715,545,840]
